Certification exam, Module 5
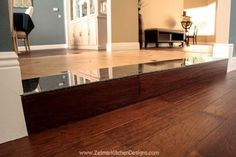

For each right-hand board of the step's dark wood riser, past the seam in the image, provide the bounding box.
[139,60,228,99]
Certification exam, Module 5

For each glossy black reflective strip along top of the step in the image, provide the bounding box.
[22,56,222,94]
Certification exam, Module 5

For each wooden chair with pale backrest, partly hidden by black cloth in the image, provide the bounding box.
[16,6,33,53]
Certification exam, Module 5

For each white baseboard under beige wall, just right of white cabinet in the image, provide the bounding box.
[107,42,139,52]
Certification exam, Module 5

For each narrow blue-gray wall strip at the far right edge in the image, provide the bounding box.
[229,0,236,57]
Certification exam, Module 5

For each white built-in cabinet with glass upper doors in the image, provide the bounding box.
[69,0,107,50]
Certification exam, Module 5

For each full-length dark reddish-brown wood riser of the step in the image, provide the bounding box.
[22,59,228,134]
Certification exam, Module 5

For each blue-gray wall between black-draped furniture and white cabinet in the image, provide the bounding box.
[14,0,66,45]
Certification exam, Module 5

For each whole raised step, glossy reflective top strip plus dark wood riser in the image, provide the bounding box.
[21,56,227,135]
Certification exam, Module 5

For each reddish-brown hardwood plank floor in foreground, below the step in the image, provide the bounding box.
[0,72,236,157]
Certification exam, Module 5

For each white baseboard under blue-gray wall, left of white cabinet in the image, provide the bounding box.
[19,44,68,51]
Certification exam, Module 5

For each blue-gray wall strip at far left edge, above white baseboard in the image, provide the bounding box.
[0,0,12,52]
